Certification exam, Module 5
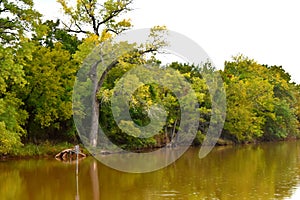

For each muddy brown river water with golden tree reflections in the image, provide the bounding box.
[0,141,300,200]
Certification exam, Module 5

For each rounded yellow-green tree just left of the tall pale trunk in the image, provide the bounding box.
[17,41,78,142]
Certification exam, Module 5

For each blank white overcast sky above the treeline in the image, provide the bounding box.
[34,0,300,83]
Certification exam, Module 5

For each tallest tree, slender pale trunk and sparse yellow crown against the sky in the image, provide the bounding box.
[57,0,132,146]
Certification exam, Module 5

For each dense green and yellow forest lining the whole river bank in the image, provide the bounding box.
[0,0,300,154]
